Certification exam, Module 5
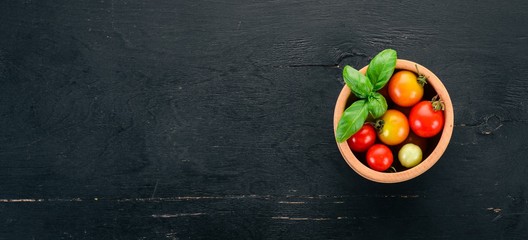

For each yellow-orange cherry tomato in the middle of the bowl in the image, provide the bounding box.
[378,109,409,146]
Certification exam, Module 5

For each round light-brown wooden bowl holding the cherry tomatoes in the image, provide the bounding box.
[334,59,454,183]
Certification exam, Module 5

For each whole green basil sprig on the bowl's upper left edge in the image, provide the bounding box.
[336,49,397,142]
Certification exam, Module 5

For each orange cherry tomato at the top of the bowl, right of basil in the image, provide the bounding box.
[389,70,424,107]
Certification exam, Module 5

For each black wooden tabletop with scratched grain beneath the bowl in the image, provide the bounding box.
[0,0,528,240]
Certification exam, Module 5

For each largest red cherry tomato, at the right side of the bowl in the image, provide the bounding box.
[409,101,444,138]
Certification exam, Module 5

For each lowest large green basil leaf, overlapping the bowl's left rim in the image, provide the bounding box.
[336,100,368,142]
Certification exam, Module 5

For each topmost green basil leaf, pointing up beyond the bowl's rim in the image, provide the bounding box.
[367,49,397,91]
